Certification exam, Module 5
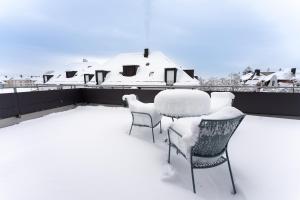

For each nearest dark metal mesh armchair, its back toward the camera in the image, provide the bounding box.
[168,115,244,194]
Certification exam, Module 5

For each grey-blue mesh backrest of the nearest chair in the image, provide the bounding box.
[191,115,245,157]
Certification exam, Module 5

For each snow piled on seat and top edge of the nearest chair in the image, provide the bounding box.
[171,106,243,156]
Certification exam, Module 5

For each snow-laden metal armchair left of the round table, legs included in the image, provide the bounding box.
[122,94,162,143]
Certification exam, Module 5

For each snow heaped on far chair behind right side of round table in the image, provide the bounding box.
[210,92,235,112]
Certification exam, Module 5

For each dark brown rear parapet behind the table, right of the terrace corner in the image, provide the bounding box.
[83,89,300,116]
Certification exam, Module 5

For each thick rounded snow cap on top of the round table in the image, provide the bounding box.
[154,89,210,117]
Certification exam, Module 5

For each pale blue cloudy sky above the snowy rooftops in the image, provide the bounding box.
[0,0,300,76]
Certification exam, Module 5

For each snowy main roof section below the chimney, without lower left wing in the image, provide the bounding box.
[91,51,198,85]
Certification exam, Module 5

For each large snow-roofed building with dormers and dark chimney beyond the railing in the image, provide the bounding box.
[47,49,199,86]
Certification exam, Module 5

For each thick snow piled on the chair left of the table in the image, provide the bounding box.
[122,94,161,126]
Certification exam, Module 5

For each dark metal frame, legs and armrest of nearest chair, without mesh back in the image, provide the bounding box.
[168,115,245,194]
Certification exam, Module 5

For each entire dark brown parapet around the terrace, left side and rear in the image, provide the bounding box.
[0,88,300,119]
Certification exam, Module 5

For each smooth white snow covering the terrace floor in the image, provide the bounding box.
[0,106,300,200]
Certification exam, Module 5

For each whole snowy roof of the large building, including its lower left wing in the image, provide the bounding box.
[47,51,199,86]
